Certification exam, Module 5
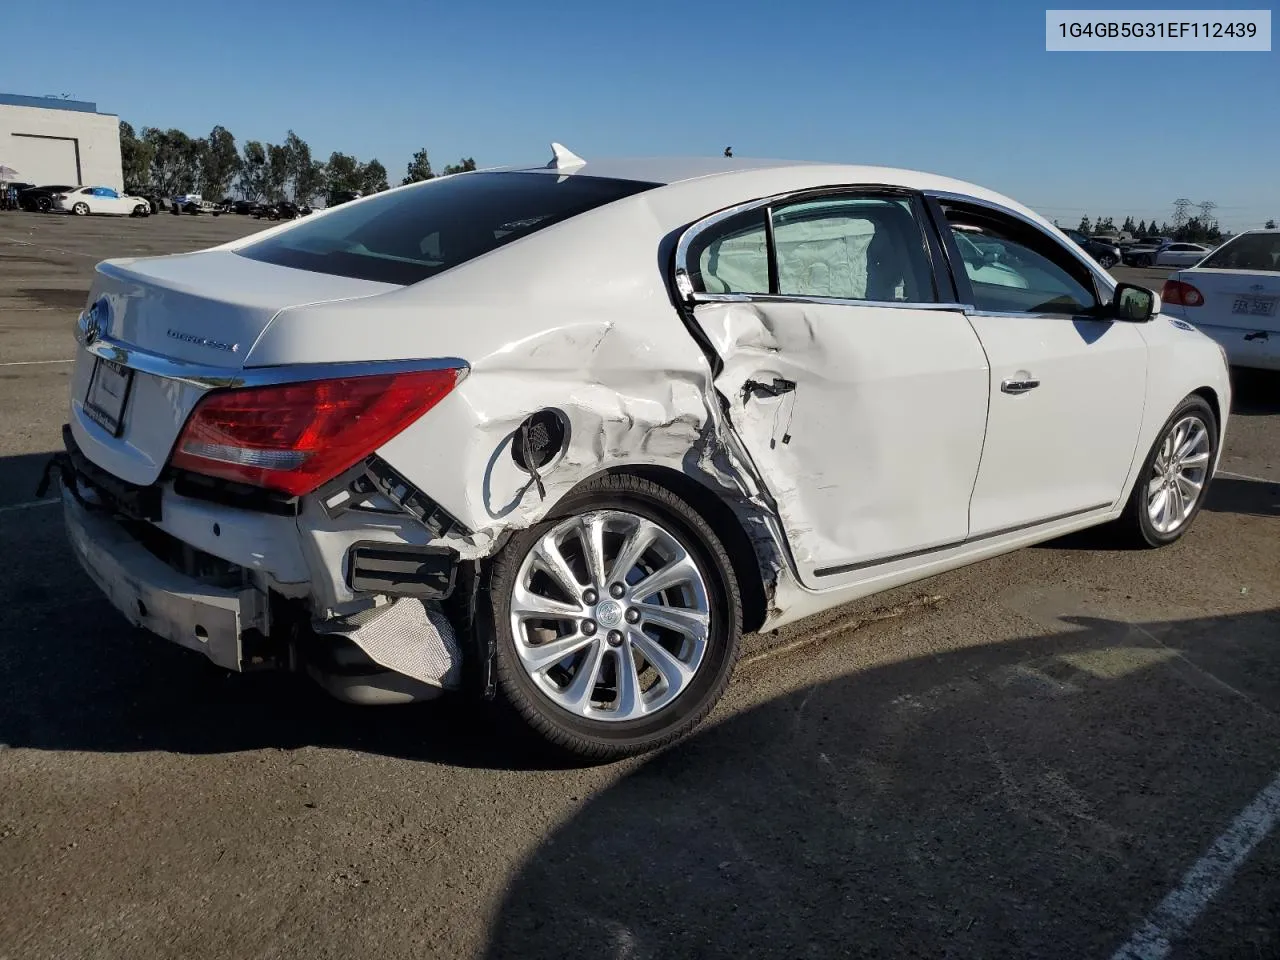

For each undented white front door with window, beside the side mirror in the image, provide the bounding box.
[934,198,1147,536]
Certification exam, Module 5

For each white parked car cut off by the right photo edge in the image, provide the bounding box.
[1164,229,1280,370]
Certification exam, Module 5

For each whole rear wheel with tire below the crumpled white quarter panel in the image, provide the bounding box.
[488,475,742,760]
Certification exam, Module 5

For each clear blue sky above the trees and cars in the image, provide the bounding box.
[0,0,1280,229]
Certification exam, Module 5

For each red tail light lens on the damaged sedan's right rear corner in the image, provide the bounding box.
[172,369,460,495]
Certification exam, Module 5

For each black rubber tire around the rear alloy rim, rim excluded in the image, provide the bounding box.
[486,485,741,756]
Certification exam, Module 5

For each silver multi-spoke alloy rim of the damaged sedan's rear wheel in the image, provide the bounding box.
[509,509,712,722]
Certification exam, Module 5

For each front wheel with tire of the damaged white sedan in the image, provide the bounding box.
[1119,394,1217,547]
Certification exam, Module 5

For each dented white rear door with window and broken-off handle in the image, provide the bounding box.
[677,188,988,589]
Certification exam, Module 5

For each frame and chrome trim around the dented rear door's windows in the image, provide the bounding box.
[673,183,960,310]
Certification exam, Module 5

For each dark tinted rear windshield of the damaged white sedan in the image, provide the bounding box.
[237,173,658,284]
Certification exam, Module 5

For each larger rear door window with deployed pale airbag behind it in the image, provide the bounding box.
[773,195,937,303]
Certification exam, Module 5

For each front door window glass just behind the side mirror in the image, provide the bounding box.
[943,205,1098,314]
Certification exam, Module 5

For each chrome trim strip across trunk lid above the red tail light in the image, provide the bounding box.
[84,337,470,390]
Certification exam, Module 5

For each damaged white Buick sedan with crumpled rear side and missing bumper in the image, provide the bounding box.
[46,146,1230,758]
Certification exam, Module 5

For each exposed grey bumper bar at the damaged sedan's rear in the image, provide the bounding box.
[63,489,269,671]
